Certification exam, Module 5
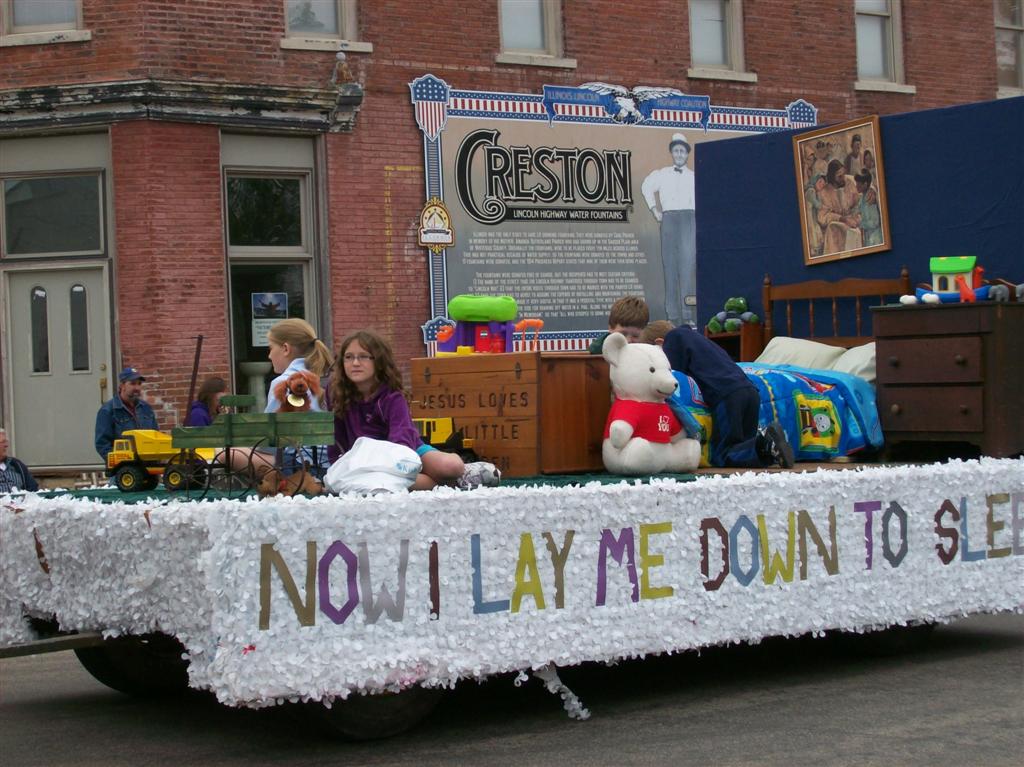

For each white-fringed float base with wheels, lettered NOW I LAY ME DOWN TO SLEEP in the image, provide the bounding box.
[0,458,1024,736]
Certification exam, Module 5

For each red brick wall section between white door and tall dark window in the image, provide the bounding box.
[111,121,228,428]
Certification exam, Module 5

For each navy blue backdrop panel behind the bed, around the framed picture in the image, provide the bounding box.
[694,97,1024,331]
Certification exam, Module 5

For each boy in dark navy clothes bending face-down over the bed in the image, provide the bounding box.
[640,319,794,469]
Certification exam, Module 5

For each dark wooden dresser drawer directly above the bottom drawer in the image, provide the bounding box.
[876,336,982,384]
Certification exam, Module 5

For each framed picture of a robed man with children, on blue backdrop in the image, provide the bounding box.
[793,115,892,265]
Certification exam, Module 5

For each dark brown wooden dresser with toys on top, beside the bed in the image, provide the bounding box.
[871,302,1024,458]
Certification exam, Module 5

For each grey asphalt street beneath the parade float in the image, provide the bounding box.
[0,614,1024,767]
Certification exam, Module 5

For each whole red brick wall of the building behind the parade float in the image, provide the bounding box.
[0,0,995,401]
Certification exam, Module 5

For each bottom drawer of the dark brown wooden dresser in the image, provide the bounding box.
[879,386,984,434]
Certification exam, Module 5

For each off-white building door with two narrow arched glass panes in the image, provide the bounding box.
[6,267,113,468]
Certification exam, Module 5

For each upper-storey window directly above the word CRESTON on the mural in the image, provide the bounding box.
[497,0,575,68]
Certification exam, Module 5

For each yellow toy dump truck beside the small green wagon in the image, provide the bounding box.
[106,429,216,493]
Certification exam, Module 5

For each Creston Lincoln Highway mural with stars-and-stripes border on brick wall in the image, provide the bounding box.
[410,75,817,353]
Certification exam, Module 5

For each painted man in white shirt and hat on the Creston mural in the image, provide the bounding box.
[640,133,697,327]
